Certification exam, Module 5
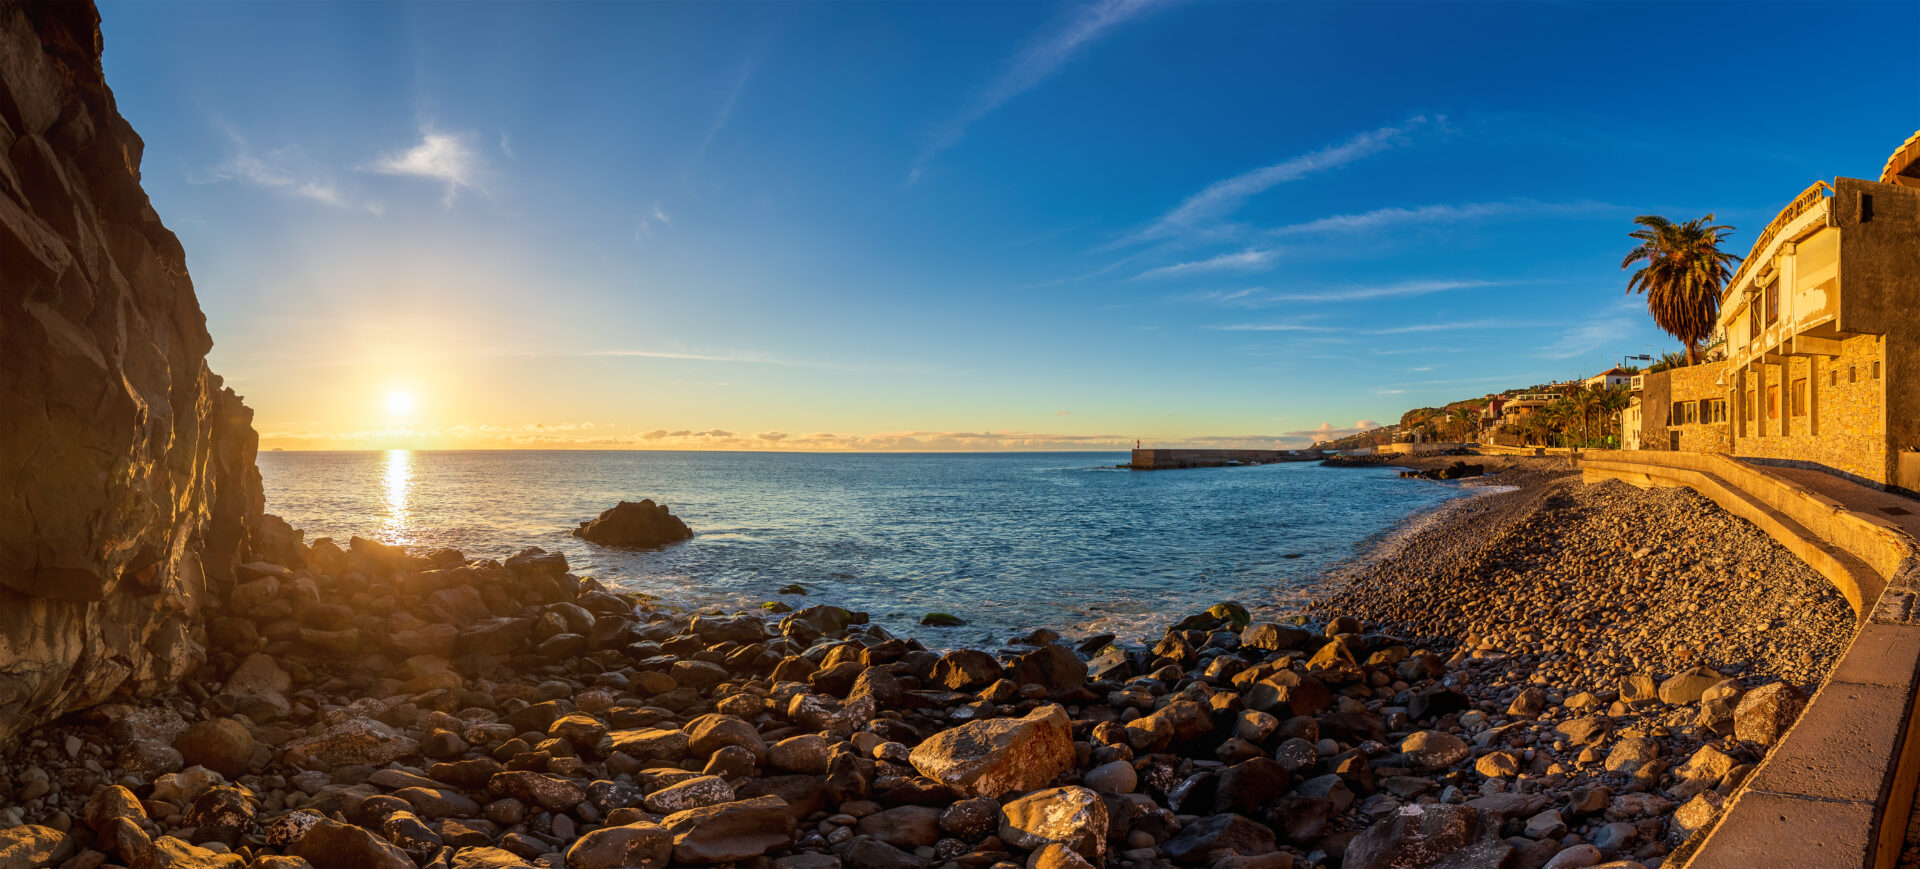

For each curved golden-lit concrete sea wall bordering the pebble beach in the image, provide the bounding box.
[1580,451,1920,869]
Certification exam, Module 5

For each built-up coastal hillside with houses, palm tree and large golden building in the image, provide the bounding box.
[1315,132,1920,493]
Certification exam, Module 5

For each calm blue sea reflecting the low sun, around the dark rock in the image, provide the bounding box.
[259,451,1463,643]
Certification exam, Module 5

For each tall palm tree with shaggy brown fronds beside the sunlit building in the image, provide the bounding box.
[1620,215,1740,364]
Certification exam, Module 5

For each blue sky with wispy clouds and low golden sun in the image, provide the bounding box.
[100,0,1920,451]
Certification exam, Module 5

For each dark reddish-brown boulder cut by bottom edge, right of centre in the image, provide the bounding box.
[1340,804,1513,869]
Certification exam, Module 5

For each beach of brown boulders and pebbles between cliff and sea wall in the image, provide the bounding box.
[0,457,1853,869]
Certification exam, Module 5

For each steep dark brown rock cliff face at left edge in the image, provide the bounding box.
[0,0,261,742]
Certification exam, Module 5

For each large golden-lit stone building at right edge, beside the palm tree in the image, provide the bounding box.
[1622,132,1920,491]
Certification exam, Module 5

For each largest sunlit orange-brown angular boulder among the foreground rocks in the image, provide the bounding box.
[908,704,1073,798]
